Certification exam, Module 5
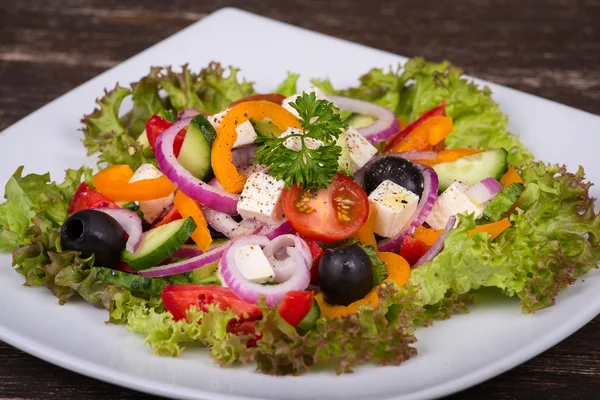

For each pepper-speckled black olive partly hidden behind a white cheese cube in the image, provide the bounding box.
[365,156,423,197]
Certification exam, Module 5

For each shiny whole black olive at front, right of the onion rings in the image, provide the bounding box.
[319,244,373,306]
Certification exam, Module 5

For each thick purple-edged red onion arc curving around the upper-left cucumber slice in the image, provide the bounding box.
[156,118,239,215]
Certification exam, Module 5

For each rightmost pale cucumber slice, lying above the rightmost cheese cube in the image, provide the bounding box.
[433,149,508,193]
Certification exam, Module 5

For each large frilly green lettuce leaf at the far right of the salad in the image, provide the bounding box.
[410,162,600,312]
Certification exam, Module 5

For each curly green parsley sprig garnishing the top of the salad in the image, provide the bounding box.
[254,93,347,189]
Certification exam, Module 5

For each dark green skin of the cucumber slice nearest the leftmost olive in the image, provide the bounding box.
[121,217,196,271]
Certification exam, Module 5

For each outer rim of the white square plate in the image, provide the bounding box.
[0,7,600,400]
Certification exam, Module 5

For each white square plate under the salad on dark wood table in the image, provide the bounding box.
[0,9,600,400]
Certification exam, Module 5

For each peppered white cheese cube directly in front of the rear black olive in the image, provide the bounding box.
[369,181,419,237]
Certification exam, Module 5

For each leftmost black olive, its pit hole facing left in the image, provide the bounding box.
[60,210,127,268]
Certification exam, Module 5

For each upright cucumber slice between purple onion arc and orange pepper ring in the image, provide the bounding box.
[177,114,217,182]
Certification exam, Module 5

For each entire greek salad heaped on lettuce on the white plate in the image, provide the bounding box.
[0,58,600,375]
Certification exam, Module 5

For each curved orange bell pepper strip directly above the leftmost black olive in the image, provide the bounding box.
[93,165,175,201]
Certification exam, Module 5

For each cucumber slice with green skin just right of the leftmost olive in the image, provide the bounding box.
[121,217,196,271]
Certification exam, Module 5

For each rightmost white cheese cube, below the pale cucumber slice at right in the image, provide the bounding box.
[425,181,483,229]
